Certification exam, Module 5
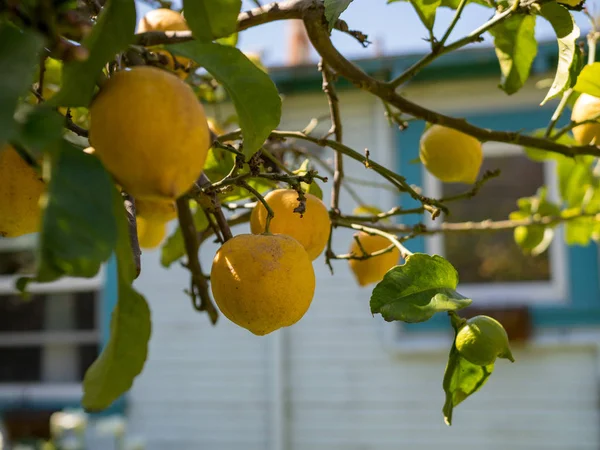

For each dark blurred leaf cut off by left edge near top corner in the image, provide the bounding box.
[0,23,44,148]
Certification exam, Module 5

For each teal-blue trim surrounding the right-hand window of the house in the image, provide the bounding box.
[396,107,600,332]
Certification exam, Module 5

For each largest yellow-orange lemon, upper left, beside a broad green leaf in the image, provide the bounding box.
[90,66,210,200]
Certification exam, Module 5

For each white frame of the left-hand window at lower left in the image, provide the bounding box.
[0,234,106,404]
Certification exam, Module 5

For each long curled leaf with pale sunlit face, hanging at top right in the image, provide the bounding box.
[540,2,582,105]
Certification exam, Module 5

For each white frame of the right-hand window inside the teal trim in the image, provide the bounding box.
[422,142,568,306]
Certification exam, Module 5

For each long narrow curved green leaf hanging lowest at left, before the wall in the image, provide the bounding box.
[82,189,152,412]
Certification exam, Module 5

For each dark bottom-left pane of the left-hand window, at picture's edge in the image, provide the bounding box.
[0,346,42,383]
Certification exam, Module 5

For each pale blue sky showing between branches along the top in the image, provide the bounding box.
[139,0,600,65]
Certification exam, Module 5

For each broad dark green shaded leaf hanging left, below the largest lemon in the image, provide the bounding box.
[36,141,117,282]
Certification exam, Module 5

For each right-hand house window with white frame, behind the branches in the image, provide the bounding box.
[424,144,566,305]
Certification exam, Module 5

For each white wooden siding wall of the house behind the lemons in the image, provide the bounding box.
[129,81,600,450]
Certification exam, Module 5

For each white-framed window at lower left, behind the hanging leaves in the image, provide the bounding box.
[0,236,103,408]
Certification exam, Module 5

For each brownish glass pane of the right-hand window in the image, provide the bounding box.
[442,154,550,283]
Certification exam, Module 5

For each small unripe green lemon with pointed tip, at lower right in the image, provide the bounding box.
[456,316,515,366]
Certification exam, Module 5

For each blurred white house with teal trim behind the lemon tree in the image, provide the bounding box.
[0,42,600,450]
